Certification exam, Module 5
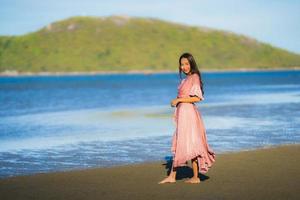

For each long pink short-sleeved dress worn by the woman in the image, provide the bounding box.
[171,74,215,173]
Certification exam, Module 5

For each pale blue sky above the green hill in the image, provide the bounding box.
[0,0,300,54]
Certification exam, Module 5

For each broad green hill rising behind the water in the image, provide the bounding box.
[0,16,300,72]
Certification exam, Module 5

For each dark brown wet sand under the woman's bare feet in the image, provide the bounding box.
[0,145,300,200]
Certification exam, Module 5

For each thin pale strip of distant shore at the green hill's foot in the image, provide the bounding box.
[0,66,300,77]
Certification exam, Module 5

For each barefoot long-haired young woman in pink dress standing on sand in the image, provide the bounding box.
[159,53,215,184]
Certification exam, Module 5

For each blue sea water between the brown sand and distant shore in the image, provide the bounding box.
[0,70,300,178]
